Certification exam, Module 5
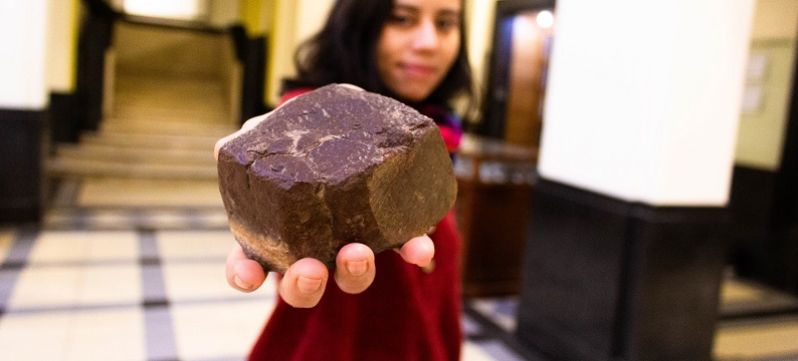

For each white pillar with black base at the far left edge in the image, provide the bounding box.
[0,0,48,223]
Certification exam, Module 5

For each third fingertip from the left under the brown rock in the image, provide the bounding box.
[335,243,377,294]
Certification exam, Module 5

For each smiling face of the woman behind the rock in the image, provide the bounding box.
[377,0,462,101]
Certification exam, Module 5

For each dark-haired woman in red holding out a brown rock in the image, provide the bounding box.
[217,0,471,360]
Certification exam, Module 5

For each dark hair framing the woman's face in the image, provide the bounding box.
[287,0,473,105]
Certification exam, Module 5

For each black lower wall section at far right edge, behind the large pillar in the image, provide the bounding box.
[730,32,798,295]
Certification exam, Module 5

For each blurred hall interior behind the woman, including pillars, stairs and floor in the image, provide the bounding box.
[0,0,798,361]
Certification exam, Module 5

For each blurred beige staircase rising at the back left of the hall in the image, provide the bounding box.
[48,74,235,180]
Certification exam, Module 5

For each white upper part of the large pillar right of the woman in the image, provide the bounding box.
[539,0,753,206]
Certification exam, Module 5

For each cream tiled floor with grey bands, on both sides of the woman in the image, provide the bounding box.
[7,205,798,361]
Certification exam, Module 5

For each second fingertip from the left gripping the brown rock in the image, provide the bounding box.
[280,258,328,308]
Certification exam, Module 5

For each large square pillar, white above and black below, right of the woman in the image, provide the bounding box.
[517,0,753,360]
